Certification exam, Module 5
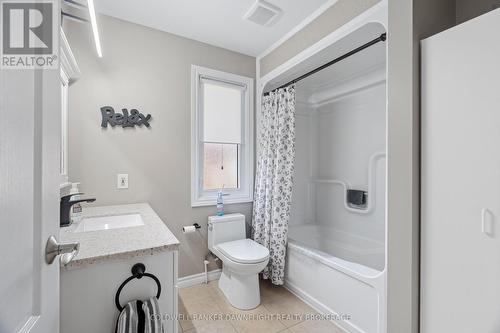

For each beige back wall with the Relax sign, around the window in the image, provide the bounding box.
[64,16,255,276]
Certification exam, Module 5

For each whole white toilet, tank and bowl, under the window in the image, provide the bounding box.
[208,214,269,310]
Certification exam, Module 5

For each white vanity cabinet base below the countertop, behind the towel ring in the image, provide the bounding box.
[60,251,177,333]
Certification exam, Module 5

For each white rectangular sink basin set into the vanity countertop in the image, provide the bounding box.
[74,214,144,232]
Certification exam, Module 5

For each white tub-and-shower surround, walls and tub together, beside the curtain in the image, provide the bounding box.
[262,23,387,333]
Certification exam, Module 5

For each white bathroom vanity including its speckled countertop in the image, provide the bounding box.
[60,203,179,333]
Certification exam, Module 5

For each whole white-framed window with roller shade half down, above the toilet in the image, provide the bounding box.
[191,66,253,207]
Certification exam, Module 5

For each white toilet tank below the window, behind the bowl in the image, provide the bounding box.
[208,214,247,250]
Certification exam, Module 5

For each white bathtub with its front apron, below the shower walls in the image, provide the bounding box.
[285,224,386,333]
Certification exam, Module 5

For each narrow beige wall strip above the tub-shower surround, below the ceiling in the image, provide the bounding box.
[260,0,381,77]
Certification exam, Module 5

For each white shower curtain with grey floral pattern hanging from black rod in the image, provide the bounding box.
[252,85,295,285]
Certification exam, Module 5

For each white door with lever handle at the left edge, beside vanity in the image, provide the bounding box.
[0,11,62,333]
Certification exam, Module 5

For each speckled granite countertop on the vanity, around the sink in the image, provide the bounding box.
[60,203,179,269]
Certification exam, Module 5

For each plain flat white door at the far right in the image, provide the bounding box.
[421,10,500,333]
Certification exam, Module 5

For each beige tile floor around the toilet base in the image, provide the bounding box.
[179,281,342,333]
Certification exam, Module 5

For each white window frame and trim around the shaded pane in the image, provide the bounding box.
[191,65,254,207]
